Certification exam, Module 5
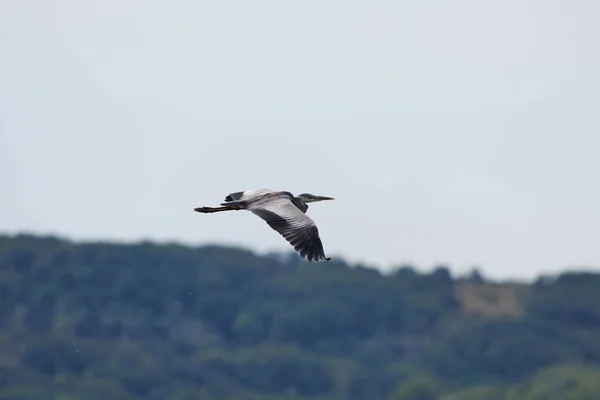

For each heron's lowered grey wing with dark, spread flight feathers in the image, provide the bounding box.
[248,197,329,261]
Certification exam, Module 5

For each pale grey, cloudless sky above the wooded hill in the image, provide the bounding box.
[0,0,600,278]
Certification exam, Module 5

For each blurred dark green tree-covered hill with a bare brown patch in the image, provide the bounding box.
[0,235,600,400]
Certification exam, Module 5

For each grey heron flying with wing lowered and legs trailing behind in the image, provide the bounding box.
[194,189,334,262]
